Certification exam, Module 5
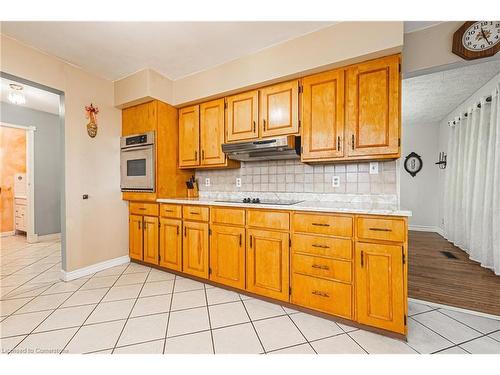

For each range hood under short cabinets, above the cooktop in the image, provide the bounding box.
[222,136,300,161]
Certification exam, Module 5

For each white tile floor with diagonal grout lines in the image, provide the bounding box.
[0,237,500,354]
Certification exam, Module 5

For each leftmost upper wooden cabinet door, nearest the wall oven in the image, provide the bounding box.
[179,105,200,167]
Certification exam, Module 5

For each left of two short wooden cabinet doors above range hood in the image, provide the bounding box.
[227,90,259,142]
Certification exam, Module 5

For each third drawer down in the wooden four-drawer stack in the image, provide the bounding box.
[292,254,352,283]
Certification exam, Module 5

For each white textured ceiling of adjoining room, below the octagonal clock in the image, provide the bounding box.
[402,59,500,126]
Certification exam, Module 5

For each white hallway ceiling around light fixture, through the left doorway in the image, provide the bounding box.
[0,78,59,115]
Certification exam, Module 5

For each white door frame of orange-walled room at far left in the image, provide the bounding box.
[0,122,38,243]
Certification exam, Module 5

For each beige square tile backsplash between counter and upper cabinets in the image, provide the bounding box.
[196,160,398,197]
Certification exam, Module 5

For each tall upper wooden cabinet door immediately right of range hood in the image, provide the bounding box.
[302,70,344,161]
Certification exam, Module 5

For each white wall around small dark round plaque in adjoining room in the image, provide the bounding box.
[399,123,439,231]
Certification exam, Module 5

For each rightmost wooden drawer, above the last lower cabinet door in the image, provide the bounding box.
[357,217,405,242]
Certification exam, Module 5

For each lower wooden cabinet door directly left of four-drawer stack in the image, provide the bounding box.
[247,229,289,301]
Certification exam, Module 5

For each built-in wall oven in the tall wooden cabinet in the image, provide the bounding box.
[120,132,155,192]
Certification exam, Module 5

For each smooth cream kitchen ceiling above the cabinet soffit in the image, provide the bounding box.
[2,22,335,80]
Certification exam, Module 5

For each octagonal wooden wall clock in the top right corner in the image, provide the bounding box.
[452,21,500,60]
